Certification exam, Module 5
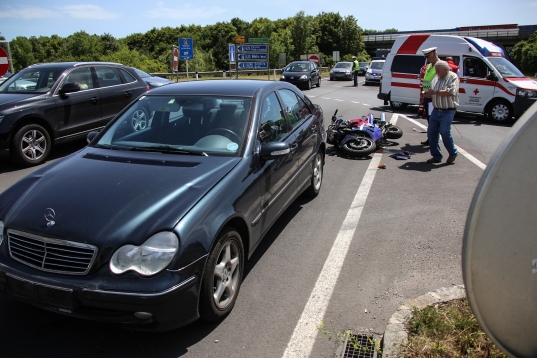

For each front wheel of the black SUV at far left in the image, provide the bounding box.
[10,124,51,166]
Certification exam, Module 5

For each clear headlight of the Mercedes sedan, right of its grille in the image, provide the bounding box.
[110,232,179,276]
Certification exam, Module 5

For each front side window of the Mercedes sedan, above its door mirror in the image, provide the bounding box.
[257,92,289,144]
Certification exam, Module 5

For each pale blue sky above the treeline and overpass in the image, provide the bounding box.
[0,0,537,40]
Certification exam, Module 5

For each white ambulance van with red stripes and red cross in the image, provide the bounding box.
[377,34,537,122]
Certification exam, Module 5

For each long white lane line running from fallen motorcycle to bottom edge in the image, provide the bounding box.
[283,153,382,358]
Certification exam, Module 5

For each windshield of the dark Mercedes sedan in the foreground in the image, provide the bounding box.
[94,95,251,157]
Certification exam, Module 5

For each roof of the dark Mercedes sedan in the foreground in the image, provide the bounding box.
[148,80,293,97]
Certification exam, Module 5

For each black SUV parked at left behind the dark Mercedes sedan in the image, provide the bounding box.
[0,62,149,166]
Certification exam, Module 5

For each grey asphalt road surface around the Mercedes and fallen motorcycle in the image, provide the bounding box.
[0,77,510,357]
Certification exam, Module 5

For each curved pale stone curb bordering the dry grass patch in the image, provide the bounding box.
[382,285,466,358]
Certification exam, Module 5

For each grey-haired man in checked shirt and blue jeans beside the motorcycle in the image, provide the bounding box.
[424,61,459,164]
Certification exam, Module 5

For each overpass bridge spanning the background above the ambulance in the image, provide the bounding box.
[364,24,537,57]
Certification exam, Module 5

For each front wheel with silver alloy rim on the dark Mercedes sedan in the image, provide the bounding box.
[199,227,244,322]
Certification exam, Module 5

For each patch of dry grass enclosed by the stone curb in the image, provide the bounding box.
[405,298,507,358]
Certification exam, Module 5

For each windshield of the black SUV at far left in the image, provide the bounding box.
[0,68,63,93]
